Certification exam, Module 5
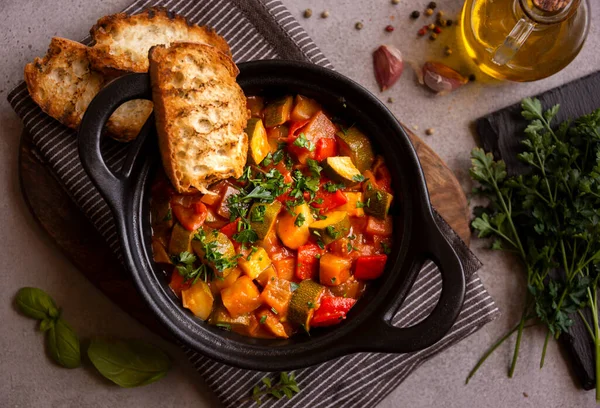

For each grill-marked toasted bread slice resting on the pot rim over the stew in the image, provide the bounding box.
[149,43,249,193]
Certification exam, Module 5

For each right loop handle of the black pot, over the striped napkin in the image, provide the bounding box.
[352,213,465,353]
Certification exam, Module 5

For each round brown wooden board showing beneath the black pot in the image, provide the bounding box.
[19,131,471,339]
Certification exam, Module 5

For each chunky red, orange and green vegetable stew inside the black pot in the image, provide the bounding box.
[151,95,394,338]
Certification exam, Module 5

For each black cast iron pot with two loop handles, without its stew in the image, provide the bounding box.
[79,61,465,371]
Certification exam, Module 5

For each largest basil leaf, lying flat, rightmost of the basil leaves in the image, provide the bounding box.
[88,338,171,388]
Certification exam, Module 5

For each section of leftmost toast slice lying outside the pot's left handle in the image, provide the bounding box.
[25,37,104,129]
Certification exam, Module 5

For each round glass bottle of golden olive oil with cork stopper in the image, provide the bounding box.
[460,0,590,81]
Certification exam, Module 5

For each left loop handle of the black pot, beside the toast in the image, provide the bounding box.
[77,74,154,214]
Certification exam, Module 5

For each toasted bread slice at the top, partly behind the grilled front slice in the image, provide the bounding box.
[89,7,230,74]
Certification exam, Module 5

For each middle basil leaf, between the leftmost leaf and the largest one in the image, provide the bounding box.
[46,318,81,368]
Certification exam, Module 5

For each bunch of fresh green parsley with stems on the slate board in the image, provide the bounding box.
[467,98,600,399]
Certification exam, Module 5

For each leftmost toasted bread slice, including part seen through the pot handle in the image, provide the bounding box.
[25,37,152,141]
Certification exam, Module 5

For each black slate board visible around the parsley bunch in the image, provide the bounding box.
[476,72,600,390]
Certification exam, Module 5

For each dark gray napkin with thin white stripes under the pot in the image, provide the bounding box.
[8,0,498,408]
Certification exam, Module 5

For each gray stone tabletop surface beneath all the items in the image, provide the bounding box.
[0,0,600,408]
